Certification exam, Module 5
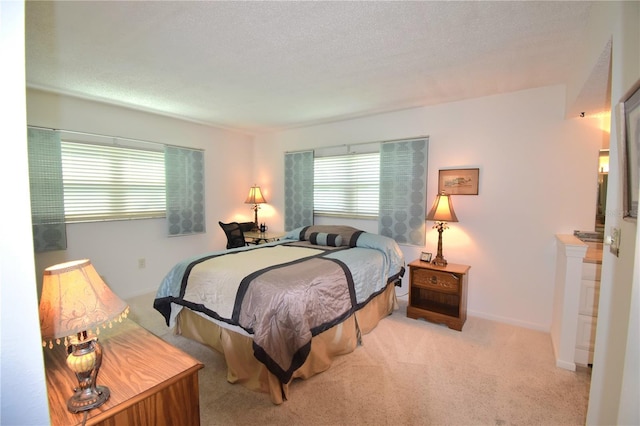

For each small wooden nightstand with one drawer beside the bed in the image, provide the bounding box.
[407,260,471,331]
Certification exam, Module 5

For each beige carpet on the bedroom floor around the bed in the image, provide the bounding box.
[128,294,590,425]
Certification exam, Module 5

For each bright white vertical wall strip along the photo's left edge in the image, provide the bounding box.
[0,1,49,425]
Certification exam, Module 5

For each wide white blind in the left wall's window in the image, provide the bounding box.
[61,141,165,222]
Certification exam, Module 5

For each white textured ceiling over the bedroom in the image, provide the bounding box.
[26,1,608,133]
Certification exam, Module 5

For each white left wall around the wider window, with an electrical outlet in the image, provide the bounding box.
[27,90,253,298]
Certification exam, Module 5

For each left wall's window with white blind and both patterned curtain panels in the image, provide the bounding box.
[27,125,206,240]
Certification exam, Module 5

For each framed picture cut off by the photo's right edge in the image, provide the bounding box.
[619,80,640,219]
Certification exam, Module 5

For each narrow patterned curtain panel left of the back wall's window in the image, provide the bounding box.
[284,151,313,231]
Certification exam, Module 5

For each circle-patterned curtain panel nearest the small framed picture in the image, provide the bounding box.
[378,139,429,246]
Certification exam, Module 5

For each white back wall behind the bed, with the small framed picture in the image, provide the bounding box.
[256,86,602,331]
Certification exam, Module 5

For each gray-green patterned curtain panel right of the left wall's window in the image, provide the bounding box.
[164,146,205,236]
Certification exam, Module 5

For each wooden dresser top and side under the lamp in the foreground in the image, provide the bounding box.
[43,320,203,426]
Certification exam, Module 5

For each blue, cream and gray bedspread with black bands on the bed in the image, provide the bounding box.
[154,226,404,383]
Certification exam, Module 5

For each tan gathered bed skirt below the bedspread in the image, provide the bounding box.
[175,283,398,404]
